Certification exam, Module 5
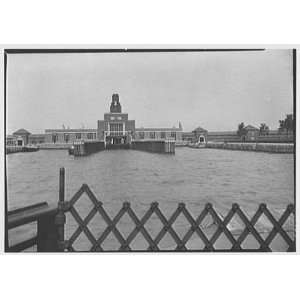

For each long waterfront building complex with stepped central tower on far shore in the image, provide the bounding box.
[6,93,294,148]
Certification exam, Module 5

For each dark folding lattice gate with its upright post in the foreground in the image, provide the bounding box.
[56,169,295,252]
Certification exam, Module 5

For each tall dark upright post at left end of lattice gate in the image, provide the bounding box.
[55,168,66,252]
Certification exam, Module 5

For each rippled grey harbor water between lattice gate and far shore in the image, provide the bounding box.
[6,147,294,250]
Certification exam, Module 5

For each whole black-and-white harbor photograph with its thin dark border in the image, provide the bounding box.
[3,45,297,255]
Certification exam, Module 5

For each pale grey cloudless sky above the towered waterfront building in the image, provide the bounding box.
[6,49,293,134]
